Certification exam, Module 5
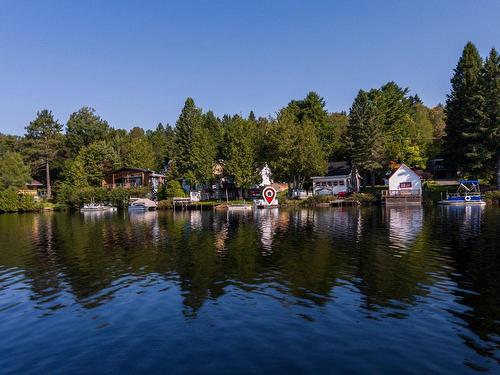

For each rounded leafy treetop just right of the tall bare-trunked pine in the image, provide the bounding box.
[65,107,110,156]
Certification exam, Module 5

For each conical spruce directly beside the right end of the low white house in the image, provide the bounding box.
[347,90,383,185]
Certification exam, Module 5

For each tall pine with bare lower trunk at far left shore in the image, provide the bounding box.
[26,109,62,199]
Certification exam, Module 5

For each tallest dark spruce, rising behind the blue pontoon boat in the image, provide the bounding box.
[445,42,487,176]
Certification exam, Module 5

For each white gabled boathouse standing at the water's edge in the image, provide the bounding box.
[382,164,422,205]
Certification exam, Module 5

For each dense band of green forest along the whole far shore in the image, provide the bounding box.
[0,42,500,209]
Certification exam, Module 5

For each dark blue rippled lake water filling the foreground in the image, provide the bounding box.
[0,207,500,375]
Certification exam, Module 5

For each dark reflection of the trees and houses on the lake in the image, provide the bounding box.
[0,207,500,357]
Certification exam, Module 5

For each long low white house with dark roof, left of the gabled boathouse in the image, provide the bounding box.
[311,161,360,195]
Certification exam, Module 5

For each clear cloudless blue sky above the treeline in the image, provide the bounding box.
[0,0,500,134]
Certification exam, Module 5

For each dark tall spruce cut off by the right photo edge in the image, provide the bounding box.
[481,48,500,190]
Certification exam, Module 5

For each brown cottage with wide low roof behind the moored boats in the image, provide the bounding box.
[103,167,165,189]
